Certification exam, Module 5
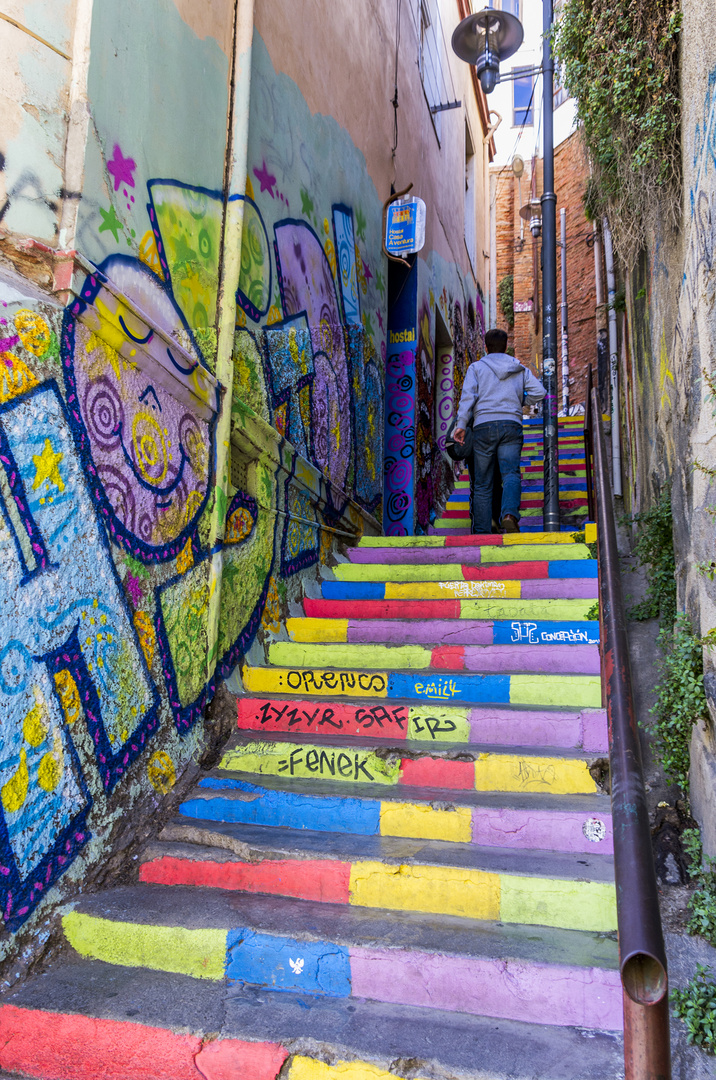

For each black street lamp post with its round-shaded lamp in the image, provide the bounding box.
[452,0,559,532]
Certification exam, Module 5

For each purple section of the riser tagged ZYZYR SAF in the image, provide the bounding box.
[470,708,609,755]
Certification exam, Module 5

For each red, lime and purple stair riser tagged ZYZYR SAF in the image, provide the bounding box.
[239,698,608,754]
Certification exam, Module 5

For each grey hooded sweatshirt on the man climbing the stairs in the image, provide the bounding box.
[455,352,546,428]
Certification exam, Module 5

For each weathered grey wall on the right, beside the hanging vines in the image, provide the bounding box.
[620,0,716,855]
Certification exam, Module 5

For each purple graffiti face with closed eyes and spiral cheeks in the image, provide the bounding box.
[63,256,217,562]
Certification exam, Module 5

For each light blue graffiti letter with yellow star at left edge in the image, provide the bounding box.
[0,381,159,928]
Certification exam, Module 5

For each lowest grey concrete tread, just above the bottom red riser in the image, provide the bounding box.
[4,957,623,1080]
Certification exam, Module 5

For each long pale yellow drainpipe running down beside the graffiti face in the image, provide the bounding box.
[205,0,254,681]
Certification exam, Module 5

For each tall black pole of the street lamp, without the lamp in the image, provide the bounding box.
[540,0,559,532]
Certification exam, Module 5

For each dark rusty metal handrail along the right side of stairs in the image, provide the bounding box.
[585,389,671,1080]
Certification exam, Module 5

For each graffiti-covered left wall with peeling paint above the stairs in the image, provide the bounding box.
[0,0,490,957]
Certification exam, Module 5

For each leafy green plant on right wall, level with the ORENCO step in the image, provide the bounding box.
[649,612,708,794]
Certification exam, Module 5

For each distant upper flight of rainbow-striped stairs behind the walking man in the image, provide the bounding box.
[430,416,587,536]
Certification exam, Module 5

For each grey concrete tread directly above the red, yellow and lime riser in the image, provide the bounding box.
[166,812,613,883]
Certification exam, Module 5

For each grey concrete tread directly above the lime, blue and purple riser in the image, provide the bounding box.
[68,885,619,970]
